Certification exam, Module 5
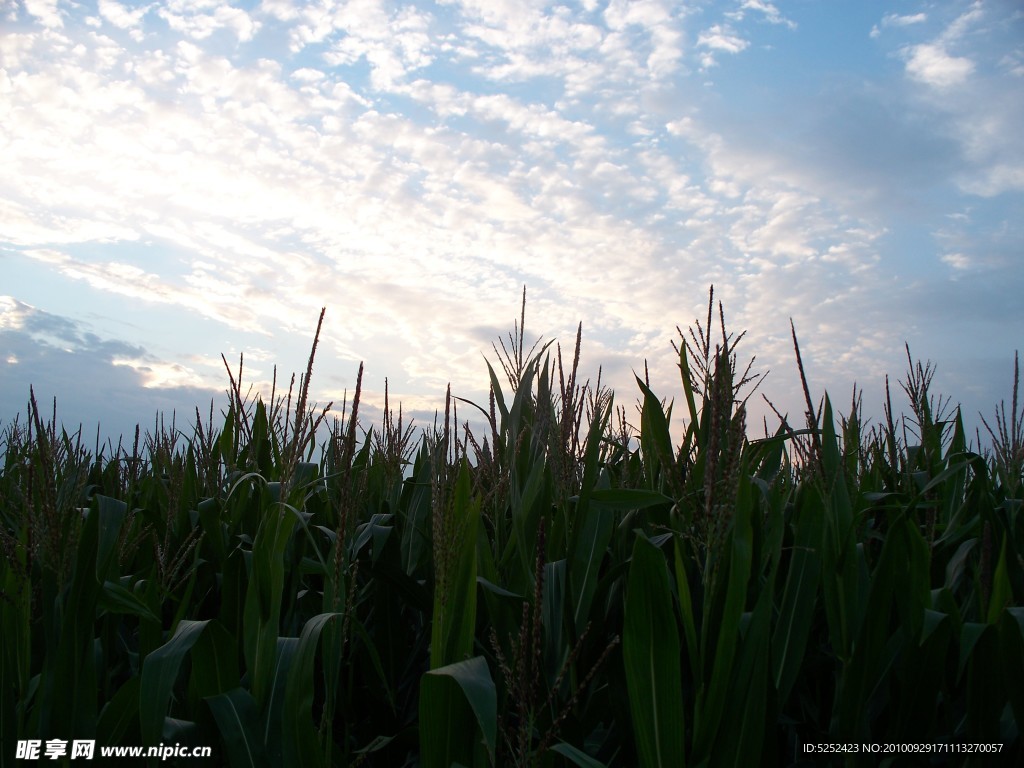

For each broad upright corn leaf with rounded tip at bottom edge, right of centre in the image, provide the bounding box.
[623,531,685,768]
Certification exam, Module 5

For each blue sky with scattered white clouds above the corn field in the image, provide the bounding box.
[0,0,1024,456]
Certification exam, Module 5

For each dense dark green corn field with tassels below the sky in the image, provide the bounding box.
[0,290,1024,768]
